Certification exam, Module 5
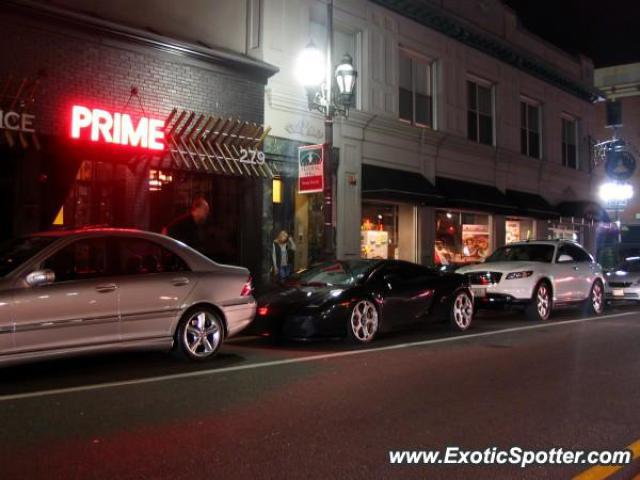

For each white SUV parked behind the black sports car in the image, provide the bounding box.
[456,240,605,320]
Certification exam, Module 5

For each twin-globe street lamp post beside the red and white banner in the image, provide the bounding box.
[297,0,358,259]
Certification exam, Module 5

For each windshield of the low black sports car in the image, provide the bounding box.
[291,260,374,286]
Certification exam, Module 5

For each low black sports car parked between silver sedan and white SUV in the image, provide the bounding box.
[251,260,474,343]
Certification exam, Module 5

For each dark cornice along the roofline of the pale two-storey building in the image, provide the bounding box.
[371,0,604,102]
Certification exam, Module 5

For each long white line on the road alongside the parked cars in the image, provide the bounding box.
[0,311,638,402]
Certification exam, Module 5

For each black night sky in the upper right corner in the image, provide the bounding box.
[503,0,640,67]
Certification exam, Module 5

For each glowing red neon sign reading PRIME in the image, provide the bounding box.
[71,105,164,150]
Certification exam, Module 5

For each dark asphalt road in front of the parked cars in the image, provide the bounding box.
[0,307,640,480]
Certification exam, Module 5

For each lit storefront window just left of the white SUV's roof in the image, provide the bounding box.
[434,210,493,265]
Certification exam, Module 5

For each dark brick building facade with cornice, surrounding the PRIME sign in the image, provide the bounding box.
[0,2,277,282]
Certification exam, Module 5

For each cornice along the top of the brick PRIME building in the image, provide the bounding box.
[0,0,279,84]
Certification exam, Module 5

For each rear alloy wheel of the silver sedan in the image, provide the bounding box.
[176,307,224,361]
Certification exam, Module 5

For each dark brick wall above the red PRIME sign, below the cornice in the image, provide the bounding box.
[0,14,264,136]
